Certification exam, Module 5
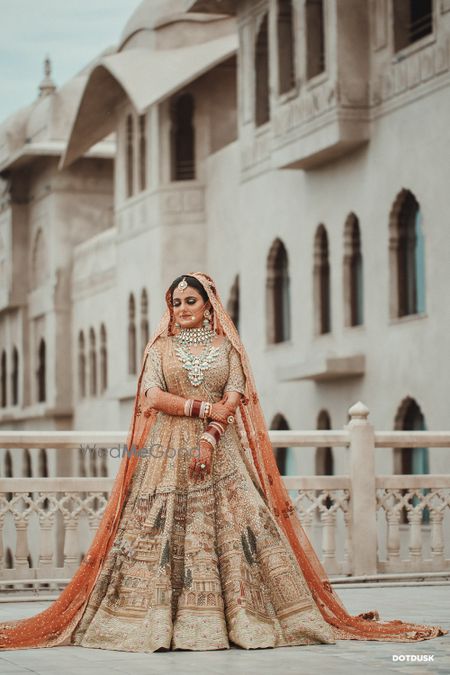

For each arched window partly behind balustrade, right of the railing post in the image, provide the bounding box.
[394,396,430,523]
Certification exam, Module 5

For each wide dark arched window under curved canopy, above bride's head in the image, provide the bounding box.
[171,94,195,180]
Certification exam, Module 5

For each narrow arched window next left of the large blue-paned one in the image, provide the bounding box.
[344,213,364,326]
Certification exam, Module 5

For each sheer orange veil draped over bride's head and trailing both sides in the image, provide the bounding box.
[0,272,447,649]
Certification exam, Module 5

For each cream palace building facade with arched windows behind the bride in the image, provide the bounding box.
[0,0,450,496]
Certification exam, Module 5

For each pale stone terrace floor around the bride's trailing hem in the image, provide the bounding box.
[0,585,450,675]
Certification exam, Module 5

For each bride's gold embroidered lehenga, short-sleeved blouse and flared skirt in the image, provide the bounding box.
[71,337,335,652]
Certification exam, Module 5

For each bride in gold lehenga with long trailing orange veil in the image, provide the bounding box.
[0,273,447,652]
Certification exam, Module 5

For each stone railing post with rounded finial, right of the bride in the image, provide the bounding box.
[347,401,377,576]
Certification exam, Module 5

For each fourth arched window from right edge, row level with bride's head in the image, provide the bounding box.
[266,238,291,343]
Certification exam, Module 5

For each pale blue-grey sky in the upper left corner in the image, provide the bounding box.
[0,0,140,123]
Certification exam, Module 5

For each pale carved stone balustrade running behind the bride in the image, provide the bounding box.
[0,402,450,591]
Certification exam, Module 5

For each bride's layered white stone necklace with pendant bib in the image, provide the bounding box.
[175,322,220,387]
